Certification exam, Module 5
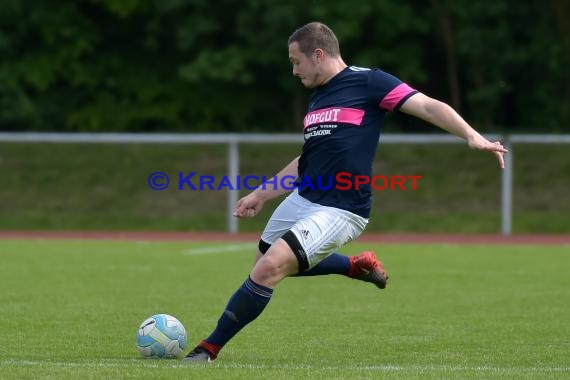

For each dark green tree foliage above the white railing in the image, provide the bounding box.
[0,0,570,132]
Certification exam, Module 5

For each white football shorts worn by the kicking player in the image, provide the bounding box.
[261,189,368,269]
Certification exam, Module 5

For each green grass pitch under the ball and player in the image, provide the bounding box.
[0,240,570,380]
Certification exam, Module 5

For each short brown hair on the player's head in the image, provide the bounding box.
[287,22,340,57]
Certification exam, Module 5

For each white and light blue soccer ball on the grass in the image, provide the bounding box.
[137,314,188,359]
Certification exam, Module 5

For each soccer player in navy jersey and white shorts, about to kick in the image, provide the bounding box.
[184,22,507,362]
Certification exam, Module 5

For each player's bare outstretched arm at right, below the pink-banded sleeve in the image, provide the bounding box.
[394,93,508,168]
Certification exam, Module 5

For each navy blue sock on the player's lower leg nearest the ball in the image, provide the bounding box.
[206,277,273,348]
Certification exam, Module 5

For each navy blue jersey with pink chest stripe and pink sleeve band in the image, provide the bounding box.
[296,66,417,218]
